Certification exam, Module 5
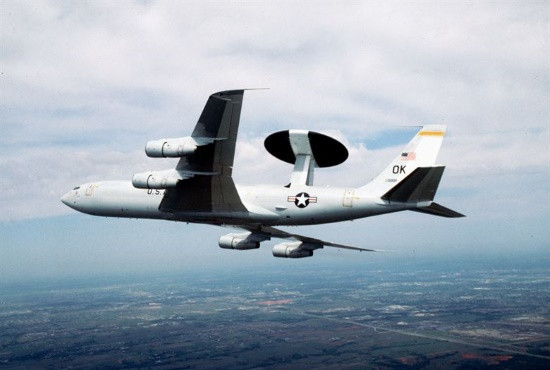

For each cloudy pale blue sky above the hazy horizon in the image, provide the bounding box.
[0,1,550,281]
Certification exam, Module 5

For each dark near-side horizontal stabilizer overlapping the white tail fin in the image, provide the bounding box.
[382,166,445,203]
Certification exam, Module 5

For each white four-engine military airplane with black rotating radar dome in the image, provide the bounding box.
[61,90,464,258]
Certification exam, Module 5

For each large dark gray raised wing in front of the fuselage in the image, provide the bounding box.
[159,90,246,213]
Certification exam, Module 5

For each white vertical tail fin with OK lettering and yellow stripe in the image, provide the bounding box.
[363,125,447,196]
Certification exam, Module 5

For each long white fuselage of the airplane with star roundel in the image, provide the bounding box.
[62,181,415,226]
